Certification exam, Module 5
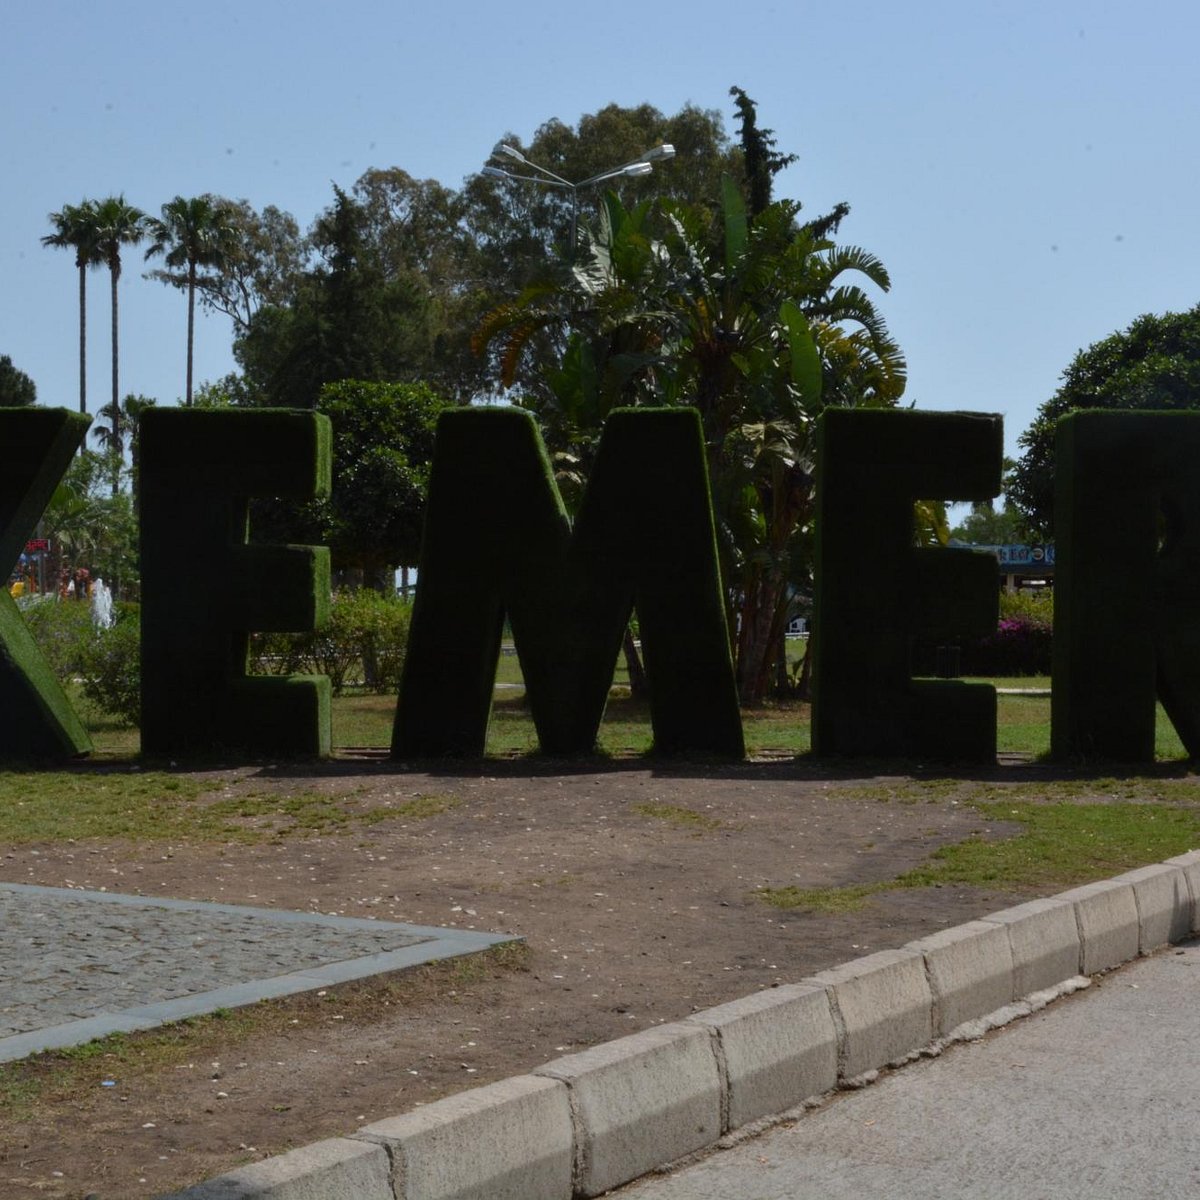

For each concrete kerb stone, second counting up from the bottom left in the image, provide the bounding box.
[354,1075,574,1200]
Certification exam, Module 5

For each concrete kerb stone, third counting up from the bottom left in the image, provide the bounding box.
[534,1022,722,1196]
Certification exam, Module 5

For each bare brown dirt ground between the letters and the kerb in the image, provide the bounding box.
[0,760,1051,1200]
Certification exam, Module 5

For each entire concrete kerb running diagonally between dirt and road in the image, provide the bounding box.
[166,851,1200,1200]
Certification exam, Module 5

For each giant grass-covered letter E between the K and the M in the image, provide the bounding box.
[140,408,330,755]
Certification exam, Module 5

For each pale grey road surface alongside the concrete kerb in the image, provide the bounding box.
[618,943,1200,1200]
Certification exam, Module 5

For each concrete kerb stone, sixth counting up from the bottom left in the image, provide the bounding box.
[905,920,1015,1037]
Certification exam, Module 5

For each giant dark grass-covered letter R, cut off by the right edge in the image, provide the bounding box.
[1050,412,1200,762]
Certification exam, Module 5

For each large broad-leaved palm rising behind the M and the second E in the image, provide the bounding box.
[476,181,905,702]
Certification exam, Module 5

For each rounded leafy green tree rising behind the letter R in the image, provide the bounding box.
[1009,305,1200,538]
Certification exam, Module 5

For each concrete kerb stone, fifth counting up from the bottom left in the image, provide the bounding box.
[802,949,934,1080]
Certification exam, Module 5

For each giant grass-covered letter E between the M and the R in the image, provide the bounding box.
[811,409,1002,761]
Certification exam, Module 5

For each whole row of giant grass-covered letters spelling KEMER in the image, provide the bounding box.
[11,398,1200,762]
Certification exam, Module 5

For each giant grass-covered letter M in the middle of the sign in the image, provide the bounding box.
[392,408,744,758]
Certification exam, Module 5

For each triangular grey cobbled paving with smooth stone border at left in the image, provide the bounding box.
[0,883,508,1062]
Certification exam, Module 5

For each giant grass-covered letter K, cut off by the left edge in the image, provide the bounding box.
[0,408,91,757]
